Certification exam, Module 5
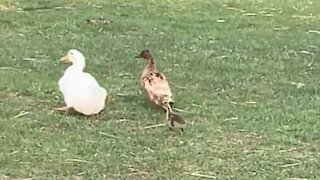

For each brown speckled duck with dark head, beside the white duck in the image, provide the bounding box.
[136,50,186,131]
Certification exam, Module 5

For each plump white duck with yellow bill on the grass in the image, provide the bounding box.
[57,49,107,115]
